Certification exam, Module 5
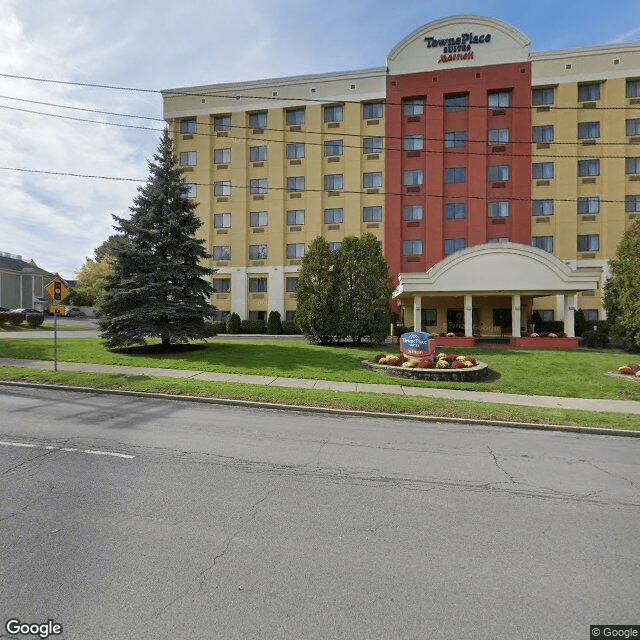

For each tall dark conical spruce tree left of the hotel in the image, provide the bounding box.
[100,129,215,349]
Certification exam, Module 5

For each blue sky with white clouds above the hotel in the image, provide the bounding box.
[0,0,640,278]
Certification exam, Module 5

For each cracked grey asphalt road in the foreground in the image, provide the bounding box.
[0,387,640,640]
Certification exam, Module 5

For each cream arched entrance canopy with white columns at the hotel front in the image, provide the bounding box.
[393,243,601,336]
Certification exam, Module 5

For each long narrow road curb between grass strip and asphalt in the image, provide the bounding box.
[0,380,640,438]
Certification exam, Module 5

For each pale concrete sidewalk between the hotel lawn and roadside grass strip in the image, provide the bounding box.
[0,358,640,414]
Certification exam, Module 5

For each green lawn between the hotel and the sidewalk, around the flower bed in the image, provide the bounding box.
[0,338,640,400]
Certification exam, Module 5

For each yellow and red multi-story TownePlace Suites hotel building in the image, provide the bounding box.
[163,16,640,336]
